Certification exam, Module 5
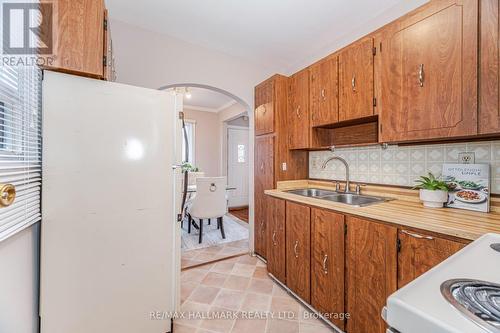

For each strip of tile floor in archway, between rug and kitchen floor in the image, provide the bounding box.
[181,239,248,269]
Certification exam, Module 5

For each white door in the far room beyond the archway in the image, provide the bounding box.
[227,126,249,207]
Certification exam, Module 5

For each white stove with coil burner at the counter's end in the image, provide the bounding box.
[384,234,500,333]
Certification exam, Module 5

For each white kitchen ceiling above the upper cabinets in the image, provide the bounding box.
[106,0,428,74]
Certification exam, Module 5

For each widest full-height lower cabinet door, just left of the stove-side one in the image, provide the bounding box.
[346,217,397,333]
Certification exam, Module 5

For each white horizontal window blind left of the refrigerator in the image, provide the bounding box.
[0,65,42,242]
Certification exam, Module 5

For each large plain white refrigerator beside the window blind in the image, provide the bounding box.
[40,71,180,333]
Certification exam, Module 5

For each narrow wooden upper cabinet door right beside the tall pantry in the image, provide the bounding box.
[287,69,310,149]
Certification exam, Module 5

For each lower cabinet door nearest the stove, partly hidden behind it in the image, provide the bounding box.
[398,230,465,288]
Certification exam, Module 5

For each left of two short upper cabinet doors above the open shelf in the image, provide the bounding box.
[310,57,339,127]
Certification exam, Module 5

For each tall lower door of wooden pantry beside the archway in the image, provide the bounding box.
[254,136,274,258]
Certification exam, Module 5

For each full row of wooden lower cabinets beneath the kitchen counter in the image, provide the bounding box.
[267,196,467,333]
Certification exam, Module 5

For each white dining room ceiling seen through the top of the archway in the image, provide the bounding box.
[184,88,237,112]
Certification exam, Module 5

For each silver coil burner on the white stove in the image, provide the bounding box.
[441,279,500,333]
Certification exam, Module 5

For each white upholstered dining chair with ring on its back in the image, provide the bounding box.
[186,177,227,244]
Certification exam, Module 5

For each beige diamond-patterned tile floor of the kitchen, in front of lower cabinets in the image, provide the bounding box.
[178,255,333,333]
